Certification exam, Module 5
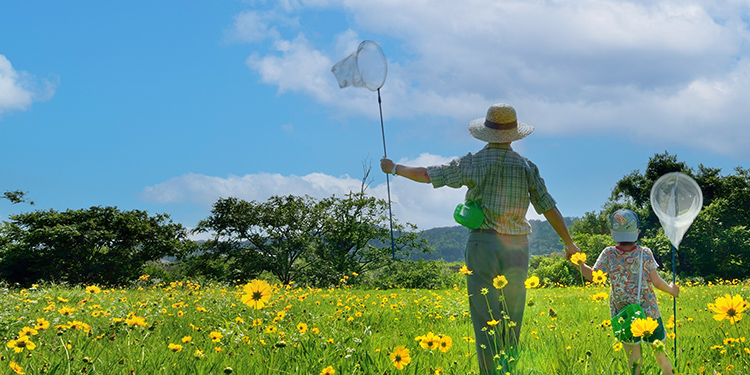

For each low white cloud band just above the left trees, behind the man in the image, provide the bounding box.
[140,154,543,229]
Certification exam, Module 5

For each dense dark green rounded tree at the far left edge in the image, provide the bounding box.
[0,207,188,285]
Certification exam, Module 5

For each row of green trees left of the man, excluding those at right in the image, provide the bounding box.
[0,189,428,286]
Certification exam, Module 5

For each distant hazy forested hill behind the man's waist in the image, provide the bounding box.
[411,217,575,262]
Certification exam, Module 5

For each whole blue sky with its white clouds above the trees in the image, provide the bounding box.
[0,0,750,235]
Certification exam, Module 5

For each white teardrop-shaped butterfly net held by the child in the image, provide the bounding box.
[651,172,703,248]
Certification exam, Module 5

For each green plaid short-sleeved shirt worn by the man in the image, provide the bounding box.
[427,143,556,235]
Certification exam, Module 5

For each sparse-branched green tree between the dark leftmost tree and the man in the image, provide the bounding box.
[194,192,427,285]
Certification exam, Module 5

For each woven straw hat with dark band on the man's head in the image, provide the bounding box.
[469,103,534,143]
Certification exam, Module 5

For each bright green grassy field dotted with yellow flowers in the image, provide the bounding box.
[0,275,750,375]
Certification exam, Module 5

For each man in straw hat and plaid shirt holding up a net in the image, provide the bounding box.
[380,104,579,374]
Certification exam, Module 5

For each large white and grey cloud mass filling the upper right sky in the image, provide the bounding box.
[232,0,750,156]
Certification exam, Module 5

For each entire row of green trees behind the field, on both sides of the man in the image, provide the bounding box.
[0,152,750,286]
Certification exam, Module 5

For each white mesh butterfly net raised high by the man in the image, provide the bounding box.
[331,40,388,91]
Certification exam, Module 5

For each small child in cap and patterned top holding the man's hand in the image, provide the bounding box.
[580,209,680,375]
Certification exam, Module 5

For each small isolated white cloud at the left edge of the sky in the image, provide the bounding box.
[0,55,57,115]
